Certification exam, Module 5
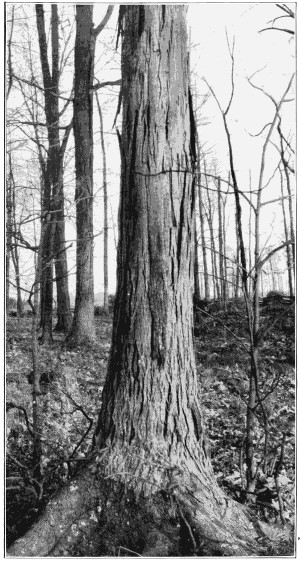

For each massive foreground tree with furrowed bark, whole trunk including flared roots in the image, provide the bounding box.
[9,5,258,556]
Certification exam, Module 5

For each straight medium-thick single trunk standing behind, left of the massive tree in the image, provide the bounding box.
[68,5,95,345]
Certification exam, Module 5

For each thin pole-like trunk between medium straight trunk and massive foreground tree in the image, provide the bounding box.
[96,94,108,310]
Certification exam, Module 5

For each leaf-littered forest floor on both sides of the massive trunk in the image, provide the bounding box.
[6,300,295,556]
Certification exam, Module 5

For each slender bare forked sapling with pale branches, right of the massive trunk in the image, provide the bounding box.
[208,36,293,494]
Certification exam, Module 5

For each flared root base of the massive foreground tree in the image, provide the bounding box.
[8,451,274,557]
